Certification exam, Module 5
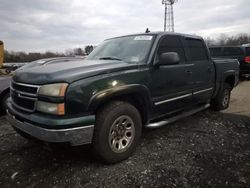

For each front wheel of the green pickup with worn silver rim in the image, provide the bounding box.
[93,101,142,164]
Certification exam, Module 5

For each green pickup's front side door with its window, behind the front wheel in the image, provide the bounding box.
[150,35,193,115]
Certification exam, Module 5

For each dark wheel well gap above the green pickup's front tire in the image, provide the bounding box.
[94,93,148,125]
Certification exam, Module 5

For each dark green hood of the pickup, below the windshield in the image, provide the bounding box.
[13,60,138,85]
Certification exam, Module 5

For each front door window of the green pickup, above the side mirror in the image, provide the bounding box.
[157,36,186,62]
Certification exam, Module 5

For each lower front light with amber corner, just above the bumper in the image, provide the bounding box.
[36,101,65,115]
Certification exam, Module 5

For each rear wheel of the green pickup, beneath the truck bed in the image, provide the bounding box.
[211,83,232,111]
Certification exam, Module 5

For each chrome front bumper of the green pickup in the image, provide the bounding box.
[7,111,94,146]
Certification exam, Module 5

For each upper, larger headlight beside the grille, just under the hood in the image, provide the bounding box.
[38,83,68,97]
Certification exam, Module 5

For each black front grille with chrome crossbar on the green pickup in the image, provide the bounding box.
[11,81,39,112]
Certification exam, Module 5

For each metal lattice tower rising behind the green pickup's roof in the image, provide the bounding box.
[162,0,178,32]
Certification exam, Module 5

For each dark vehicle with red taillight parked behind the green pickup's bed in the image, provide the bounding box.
[209,44,250,76]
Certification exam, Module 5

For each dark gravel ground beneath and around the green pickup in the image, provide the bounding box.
[0,81,250,188]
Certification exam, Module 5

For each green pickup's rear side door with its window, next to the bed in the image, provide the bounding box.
[185,38,215,103]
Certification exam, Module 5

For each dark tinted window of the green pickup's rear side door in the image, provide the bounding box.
[186,38,208,61]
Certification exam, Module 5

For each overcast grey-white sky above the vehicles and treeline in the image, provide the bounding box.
[0,0,250,52]
